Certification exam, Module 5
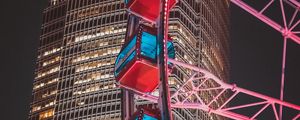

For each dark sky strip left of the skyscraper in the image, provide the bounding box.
[0,0,46,120]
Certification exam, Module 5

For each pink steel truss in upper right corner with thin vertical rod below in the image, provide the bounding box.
[231,0,300,119]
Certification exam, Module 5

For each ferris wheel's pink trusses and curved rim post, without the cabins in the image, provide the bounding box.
[120,0,300,120]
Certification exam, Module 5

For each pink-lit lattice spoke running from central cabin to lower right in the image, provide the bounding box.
[121,59,300,120]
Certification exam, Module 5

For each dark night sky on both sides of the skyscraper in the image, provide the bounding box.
[0,0,300,120]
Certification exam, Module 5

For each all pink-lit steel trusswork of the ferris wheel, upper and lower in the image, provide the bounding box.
[120,0,300,120]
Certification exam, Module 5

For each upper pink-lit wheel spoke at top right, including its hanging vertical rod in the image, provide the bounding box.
[231,0,300,120]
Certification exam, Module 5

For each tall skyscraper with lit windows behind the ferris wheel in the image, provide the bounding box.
[29,0,229,120]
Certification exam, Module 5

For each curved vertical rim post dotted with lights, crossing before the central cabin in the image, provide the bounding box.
[157,0,172,120]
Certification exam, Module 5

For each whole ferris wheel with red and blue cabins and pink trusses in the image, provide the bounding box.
[114,0,300,120]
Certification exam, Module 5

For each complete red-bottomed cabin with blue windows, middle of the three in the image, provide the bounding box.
[114,23,175,92]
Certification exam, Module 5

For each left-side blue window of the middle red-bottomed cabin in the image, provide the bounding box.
[115,36,136,76]
